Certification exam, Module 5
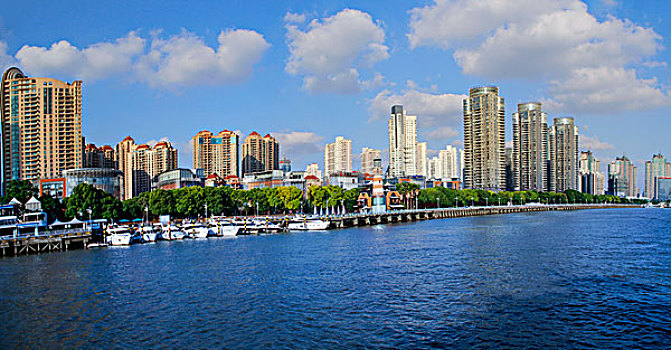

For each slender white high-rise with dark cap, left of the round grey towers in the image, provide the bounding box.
[389,105,417,178]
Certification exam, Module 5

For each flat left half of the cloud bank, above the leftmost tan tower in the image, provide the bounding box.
[16,32,145,80]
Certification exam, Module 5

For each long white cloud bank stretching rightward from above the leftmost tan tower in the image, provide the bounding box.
[8,29,270,87]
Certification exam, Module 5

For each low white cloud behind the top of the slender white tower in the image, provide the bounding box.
[369,83,467,128]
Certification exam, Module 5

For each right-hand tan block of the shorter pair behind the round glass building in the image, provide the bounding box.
[131,141,177,196]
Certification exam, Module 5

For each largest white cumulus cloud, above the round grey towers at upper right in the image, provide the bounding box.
[408,0,669,112]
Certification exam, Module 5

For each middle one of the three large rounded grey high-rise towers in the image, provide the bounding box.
[512,102,548,191]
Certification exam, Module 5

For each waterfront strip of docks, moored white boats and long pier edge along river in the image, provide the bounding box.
[0,204,638,257]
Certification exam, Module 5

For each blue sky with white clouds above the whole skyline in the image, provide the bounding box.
[0,0,671,183]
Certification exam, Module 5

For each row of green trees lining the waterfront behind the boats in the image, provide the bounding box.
[3,180,642,222]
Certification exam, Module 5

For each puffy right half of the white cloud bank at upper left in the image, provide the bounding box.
[136,29,270,87]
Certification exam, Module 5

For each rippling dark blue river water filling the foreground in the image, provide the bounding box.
[0,209,671,349]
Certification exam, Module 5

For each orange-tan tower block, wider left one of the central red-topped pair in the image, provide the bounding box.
[192,129,240,178]
